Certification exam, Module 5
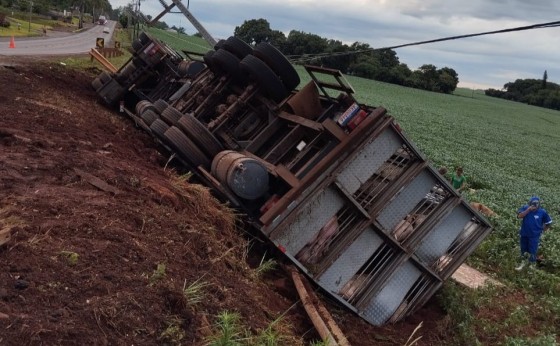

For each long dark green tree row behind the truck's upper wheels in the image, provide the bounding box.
[234,18,459,93]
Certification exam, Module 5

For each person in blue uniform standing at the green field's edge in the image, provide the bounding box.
[515,197,552,270]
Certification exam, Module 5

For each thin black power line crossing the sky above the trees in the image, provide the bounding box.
[288,21,560,62]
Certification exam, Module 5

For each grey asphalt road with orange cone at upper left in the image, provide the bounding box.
[0,20,116,56]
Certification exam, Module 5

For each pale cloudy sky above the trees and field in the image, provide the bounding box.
[109,0,560,89]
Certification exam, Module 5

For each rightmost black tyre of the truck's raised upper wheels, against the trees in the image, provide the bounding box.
[253,42,300,91]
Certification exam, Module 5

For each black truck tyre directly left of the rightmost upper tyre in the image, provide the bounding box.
[239,55,289,102]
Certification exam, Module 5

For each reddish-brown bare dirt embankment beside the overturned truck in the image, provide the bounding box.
[0,60,448,345]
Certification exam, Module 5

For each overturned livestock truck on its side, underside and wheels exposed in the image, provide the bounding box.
[92,33,491,325]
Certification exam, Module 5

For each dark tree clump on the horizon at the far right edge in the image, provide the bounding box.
[484,71,560,110]
